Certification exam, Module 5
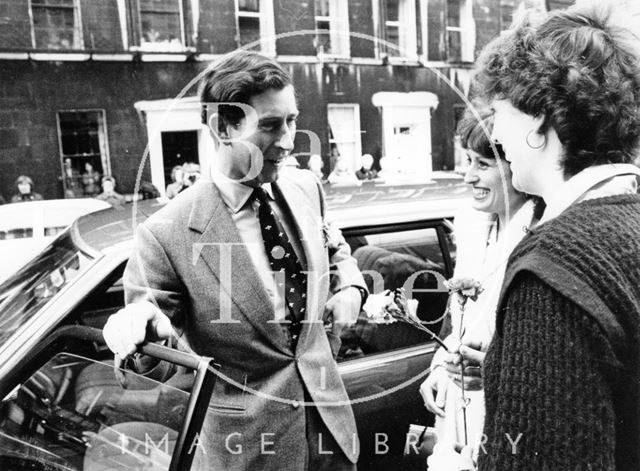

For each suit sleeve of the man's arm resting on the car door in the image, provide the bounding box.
[123,223,187,325]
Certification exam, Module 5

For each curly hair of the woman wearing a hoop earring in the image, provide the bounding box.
[474,3,640,177]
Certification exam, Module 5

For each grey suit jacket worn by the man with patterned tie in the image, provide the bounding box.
[124,169,365,470]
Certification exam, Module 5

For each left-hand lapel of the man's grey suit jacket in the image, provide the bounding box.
[189,182,291,355]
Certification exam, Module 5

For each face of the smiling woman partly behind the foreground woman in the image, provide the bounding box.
[464,149,524,218]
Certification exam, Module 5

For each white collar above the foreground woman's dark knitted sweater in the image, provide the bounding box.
[540,164,640,224]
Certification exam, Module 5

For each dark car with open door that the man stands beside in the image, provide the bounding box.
[0,178,470,471]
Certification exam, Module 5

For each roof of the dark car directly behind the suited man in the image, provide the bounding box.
[74,178,470,251]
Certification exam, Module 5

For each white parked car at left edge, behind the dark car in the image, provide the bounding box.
[0,198,109,281]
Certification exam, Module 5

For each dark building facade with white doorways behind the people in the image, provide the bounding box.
[0,0,561,198]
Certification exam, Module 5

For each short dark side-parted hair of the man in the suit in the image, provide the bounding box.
[199,50,291,131]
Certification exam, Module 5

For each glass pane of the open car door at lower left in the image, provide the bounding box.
[0,353,193,471]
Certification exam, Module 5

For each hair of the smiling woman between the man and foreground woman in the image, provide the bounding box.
[457,102,504,159]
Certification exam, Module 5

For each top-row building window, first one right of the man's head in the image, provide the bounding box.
[314,0,350,57]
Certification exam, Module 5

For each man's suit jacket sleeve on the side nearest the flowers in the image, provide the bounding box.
[315,175,367,294]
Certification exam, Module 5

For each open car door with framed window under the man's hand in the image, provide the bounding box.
[0,326,220,471]
